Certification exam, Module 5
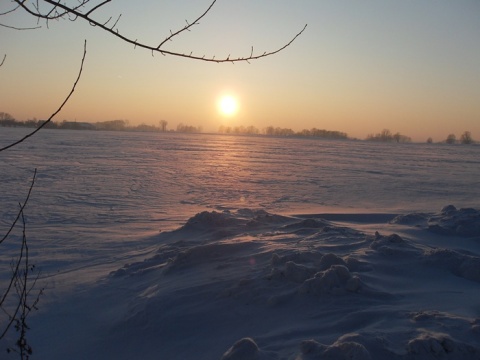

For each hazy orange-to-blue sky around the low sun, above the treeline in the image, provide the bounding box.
[0,0,480,142]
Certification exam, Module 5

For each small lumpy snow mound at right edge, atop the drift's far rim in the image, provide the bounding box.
[428,205,480,237]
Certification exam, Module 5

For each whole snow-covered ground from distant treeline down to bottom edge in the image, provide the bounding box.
[0,128,480,360]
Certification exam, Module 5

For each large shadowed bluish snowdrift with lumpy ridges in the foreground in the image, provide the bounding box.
[31,206,480,360]
